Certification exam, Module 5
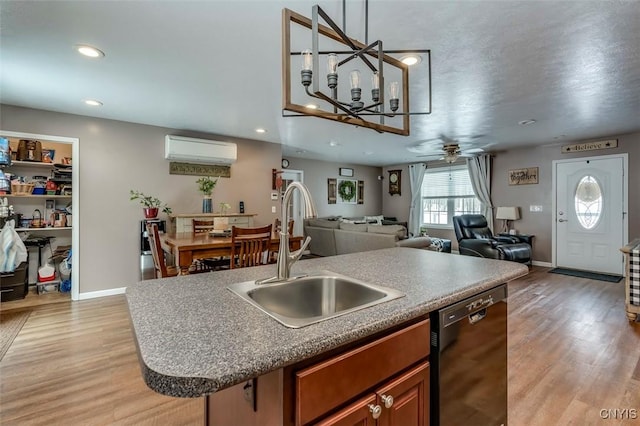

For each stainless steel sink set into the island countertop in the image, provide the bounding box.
[227,271,404,328]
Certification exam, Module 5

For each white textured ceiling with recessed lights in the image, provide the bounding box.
[0,0,640,165]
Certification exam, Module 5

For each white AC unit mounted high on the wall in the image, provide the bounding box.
[164,135,237,164]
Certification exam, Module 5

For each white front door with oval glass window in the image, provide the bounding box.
[554,156,626,275]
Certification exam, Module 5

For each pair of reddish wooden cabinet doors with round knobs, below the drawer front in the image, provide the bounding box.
[318,361,429,426]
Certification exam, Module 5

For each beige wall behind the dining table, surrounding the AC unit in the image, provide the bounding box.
[0,105,281,294]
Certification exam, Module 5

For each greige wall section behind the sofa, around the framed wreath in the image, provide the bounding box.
[287,157,383,217]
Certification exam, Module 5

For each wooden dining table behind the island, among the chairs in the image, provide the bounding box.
[160,232,304,275]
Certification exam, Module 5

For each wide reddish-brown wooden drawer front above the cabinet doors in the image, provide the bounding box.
[295,320,430,425]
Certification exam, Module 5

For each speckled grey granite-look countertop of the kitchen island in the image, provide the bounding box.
[126,247,528,397]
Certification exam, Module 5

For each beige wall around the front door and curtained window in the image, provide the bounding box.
[382,133,640,262]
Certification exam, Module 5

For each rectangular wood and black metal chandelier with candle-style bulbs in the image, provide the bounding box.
[282,0,431,136]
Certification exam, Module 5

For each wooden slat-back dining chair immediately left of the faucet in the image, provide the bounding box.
[229,225,273,269]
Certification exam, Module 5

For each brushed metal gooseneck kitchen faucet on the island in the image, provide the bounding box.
[256,182,317,284]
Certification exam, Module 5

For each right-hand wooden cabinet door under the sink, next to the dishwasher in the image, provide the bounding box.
[376,362,429,426]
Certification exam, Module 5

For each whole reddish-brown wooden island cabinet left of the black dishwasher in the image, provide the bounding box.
[206,319,430,426]
